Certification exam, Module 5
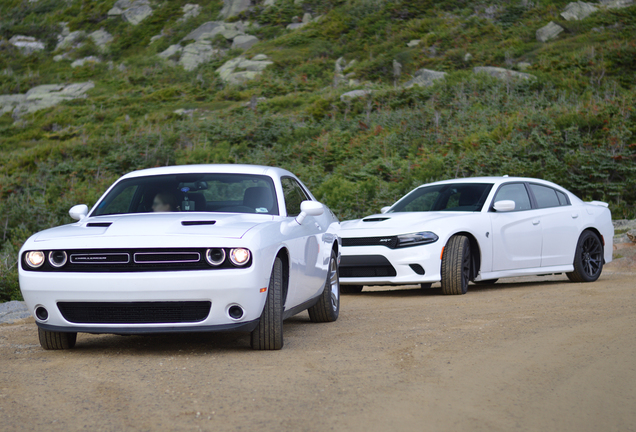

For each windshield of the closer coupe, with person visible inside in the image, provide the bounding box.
[91,173,278,216]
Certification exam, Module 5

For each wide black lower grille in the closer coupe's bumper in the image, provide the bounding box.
[57,301,212,324]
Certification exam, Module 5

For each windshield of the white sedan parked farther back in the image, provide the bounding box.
[389,183,493,213]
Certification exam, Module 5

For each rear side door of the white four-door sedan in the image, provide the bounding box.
[528,183,580,267]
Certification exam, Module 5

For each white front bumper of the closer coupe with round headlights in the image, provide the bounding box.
[20,267,269,334]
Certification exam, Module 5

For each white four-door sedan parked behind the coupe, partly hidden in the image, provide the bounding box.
[340,176,614,294]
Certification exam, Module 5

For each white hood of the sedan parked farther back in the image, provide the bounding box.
[340,212,473,233]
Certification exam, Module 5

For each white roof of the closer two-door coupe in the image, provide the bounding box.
[122,164,296,179]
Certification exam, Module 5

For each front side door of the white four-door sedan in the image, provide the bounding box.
[489,182,543,271]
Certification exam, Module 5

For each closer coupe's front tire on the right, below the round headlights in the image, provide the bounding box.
[250,257,283,350]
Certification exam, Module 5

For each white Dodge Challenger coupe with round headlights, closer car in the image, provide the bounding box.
[19,165,340,350]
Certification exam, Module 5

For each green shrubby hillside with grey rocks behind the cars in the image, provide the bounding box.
[0,0,636,299]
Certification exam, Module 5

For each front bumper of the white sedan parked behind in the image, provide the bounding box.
[340,242,442,285]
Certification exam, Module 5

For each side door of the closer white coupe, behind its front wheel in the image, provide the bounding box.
[281,177,325,309]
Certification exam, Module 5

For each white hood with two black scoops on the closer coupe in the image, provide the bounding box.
[33,213,274,242]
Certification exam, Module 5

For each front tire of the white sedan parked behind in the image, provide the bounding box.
[442,235,470,295]
